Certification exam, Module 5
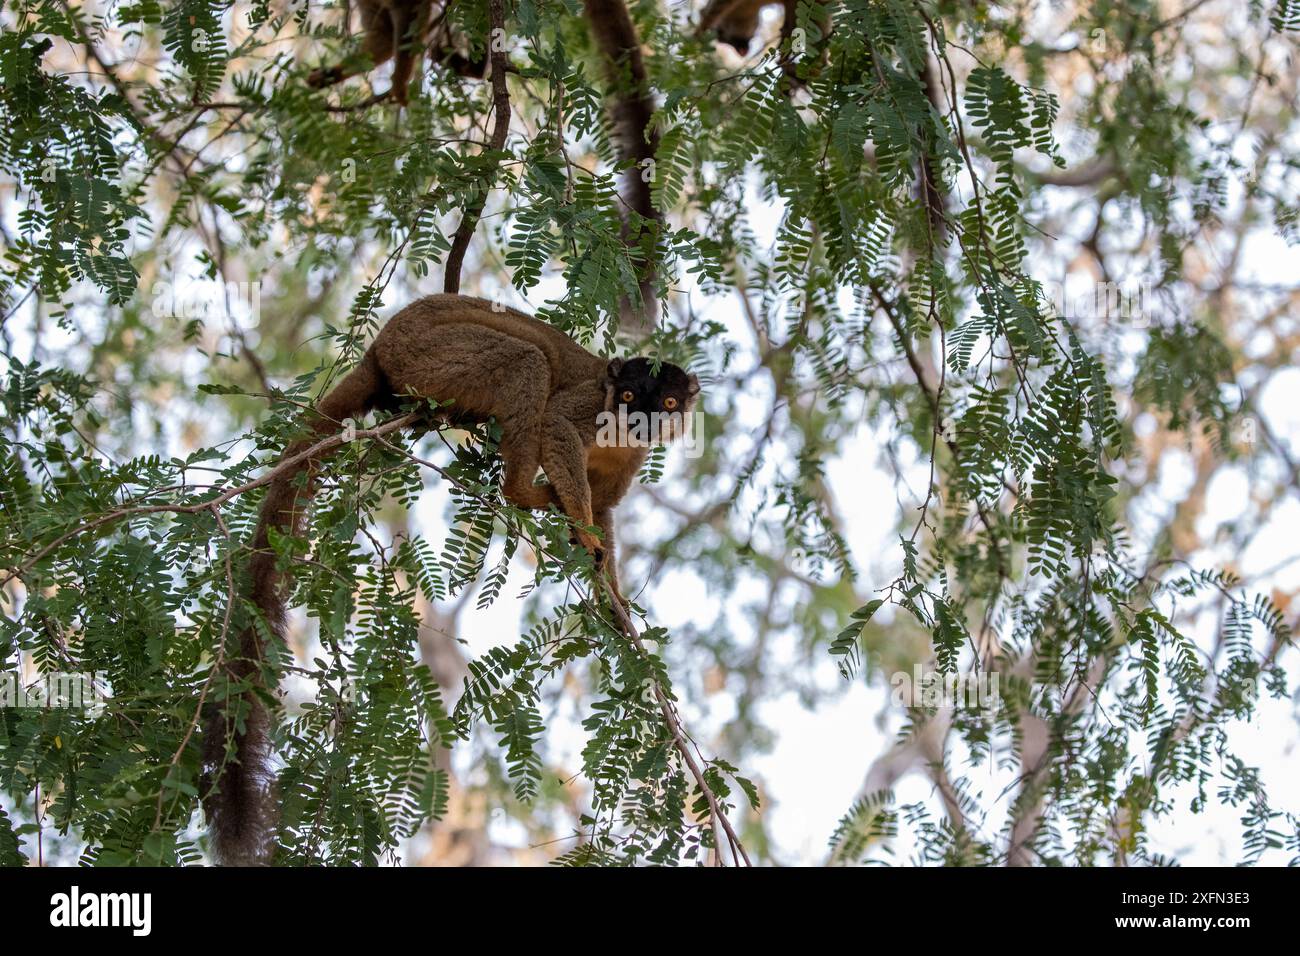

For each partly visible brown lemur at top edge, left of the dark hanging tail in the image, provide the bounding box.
[307,0,488,105]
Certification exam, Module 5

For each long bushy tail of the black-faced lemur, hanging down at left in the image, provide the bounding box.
[200,352,386,866]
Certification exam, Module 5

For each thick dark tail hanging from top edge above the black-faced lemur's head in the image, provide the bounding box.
[582,0,663,328]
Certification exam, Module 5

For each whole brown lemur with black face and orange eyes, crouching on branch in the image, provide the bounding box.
[202,295,699,865]
